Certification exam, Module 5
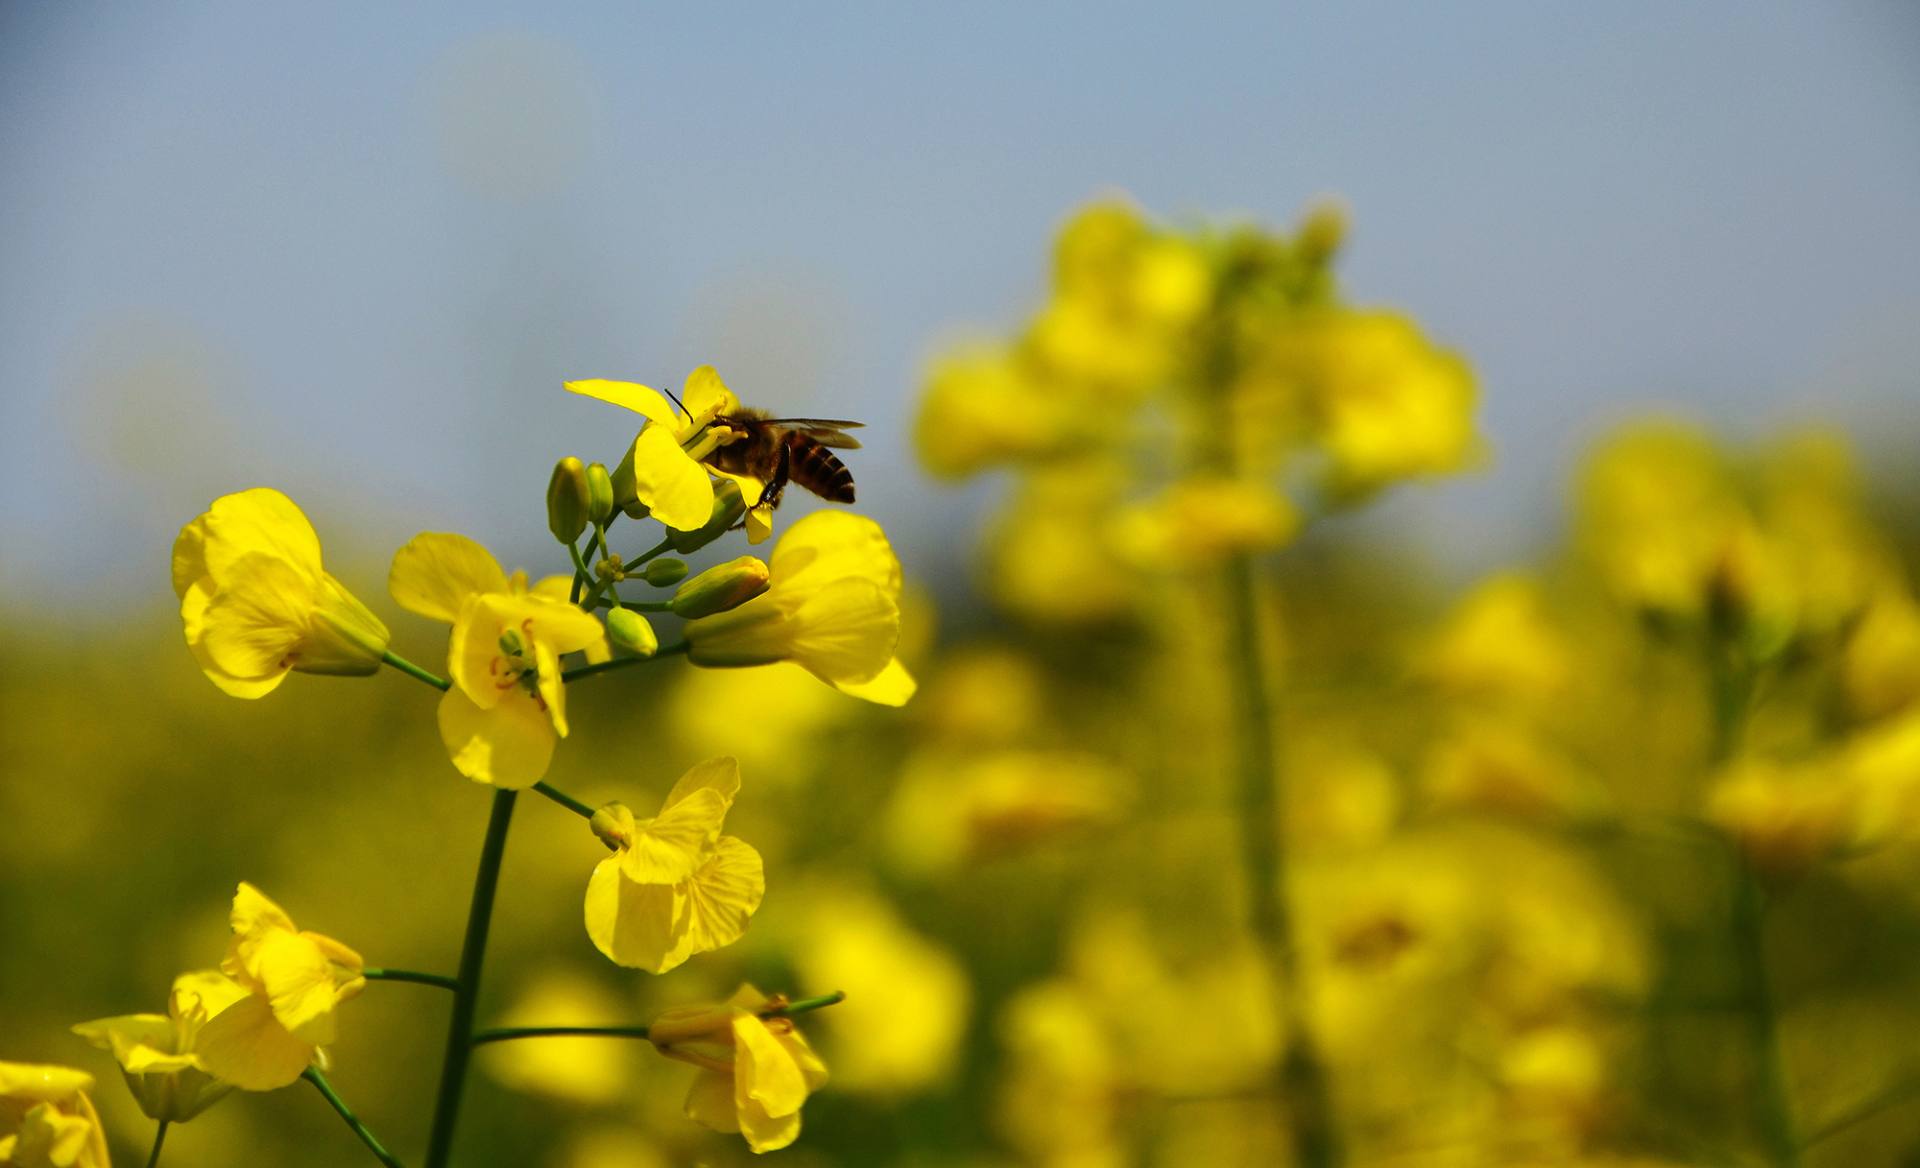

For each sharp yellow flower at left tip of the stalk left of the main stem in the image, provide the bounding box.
[194,884,367,1091]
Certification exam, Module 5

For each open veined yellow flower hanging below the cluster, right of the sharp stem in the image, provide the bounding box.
[586,759,766,974]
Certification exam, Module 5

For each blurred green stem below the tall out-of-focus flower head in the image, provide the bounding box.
[1225,555,1342,1168]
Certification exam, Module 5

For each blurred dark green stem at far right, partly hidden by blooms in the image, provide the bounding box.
[1707,636,1801,1168]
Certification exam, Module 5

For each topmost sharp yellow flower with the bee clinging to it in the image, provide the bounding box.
[566,365,774,544]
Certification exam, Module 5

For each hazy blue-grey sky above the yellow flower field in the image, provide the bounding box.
[0,0,1920,611]
